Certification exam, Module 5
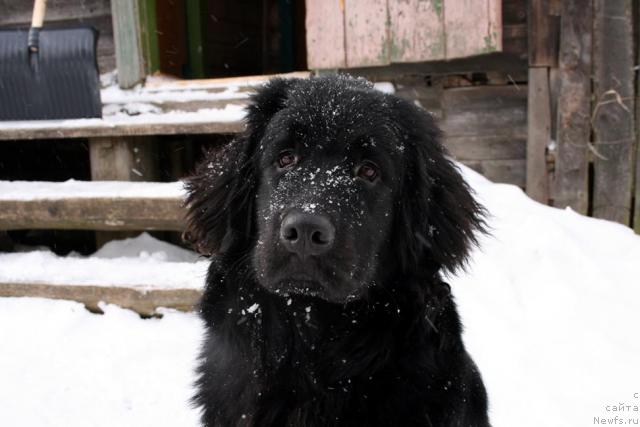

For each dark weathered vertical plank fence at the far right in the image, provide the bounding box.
[526,0,640,232]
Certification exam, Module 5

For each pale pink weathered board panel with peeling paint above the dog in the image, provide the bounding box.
[306,0,503,69]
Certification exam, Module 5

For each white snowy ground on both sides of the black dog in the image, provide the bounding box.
[0,165,640,427]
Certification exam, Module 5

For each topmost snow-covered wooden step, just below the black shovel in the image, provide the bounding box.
[0,72,310,140]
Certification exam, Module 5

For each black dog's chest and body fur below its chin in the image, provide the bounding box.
[197,264,484,426]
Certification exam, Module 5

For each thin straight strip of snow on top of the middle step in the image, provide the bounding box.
[0,179,185,201]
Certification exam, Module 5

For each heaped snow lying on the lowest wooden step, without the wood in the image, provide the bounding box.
[0,233,208,290]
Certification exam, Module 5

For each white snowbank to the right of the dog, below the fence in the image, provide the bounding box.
[451,169,640,427]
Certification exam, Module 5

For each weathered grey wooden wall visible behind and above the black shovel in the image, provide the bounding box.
[0,0,116,73]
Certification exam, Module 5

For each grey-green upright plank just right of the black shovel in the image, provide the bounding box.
[111,0,146,88]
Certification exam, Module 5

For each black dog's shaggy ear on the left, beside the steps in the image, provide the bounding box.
[183,79,296,256]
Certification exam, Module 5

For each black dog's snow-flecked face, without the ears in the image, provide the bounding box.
[253,87,404,302]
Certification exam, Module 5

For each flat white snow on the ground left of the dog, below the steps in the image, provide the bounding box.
[0,298,201,427]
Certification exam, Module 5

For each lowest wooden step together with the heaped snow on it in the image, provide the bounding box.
[0,233,208,314]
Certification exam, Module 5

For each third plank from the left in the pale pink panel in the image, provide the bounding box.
[388,0,446,62]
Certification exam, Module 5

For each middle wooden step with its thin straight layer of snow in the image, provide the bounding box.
[0,181,184,231]
